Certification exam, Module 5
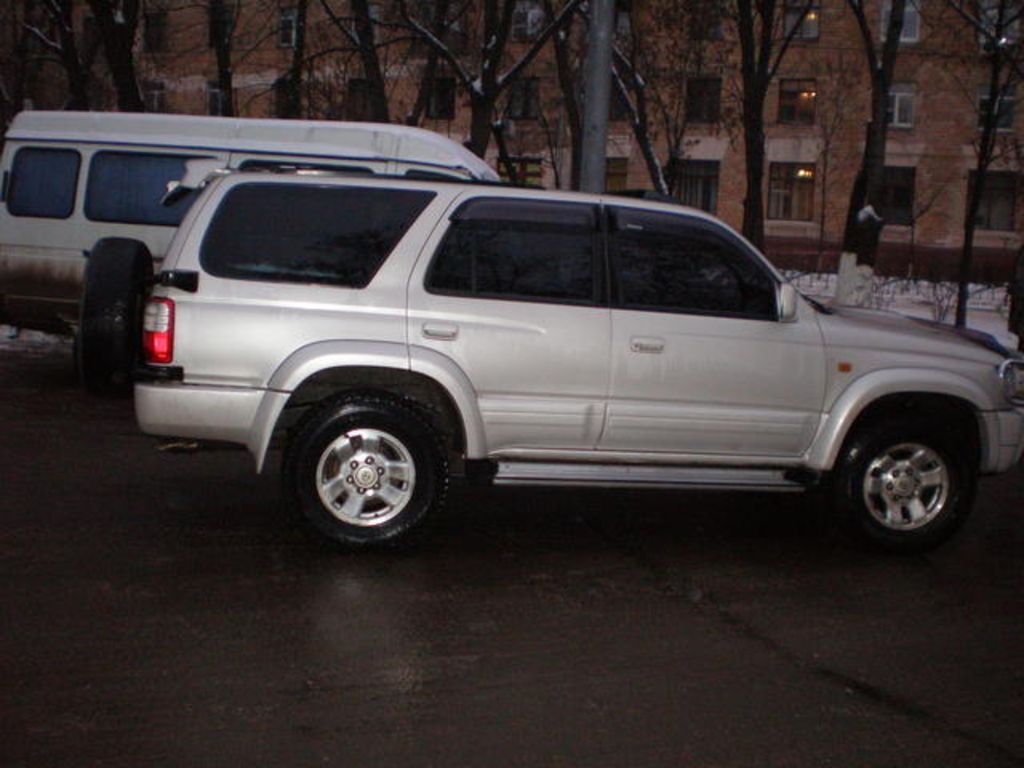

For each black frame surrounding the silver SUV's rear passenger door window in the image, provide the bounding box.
[423,197,607,307]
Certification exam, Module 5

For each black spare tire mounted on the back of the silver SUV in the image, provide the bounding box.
[75,238,153,396]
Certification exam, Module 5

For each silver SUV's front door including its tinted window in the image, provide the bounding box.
[600,207,824,458]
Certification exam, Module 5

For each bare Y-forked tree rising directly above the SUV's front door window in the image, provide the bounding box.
[725,0,814,248]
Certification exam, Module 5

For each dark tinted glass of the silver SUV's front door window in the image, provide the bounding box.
[610,209,775,319]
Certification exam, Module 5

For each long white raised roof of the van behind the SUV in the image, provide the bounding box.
[7,111,499,181]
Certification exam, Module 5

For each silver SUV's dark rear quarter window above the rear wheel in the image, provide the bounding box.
[200,182,434,288]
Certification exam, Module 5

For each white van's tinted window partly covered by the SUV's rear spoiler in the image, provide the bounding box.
[85,152,204,226]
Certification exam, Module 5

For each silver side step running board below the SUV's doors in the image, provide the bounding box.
[492,461,809,492]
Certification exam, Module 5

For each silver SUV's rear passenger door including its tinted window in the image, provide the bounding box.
[409,197,610,454]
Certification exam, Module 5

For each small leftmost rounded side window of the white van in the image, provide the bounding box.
[7,147,82,219]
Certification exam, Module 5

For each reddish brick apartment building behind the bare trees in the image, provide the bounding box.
[2,0,1024,280]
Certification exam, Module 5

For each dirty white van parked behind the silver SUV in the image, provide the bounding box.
[0,112,498,333]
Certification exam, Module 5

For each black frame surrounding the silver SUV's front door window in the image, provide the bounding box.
[605,206,779,323]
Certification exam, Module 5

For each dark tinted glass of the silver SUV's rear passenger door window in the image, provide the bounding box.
[426,198,598,303]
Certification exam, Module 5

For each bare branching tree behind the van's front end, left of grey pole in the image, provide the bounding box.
[398,0,582,158]
